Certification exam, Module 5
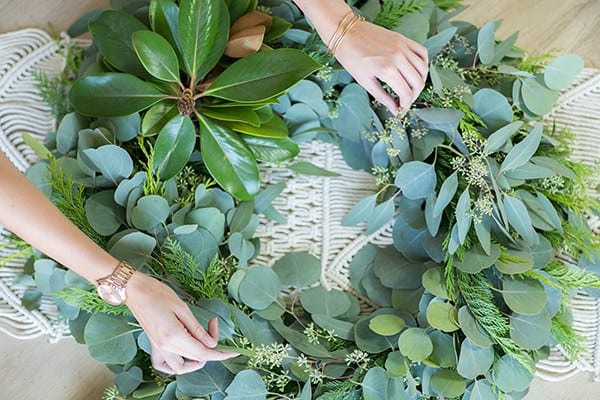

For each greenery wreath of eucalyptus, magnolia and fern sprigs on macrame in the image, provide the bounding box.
[9,0,600,400]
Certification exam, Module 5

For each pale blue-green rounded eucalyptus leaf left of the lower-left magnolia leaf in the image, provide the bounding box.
[83,144,133,186]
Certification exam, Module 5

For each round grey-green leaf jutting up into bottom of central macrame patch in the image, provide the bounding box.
[272,252,321,288]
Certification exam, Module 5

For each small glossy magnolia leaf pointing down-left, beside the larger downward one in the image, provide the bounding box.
[153,115,196,181]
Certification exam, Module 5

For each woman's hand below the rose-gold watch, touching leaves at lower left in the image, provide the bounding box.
[126,272,237,374]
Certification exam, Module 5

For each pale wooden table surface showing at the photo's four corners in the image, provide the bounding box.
[0,0,600,400]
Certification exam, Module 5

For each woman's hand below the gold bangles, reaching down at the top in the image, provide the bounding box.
[335,21,428,114]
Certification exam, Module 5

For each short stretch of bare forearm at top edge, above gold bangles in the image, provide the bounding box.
[294,0,352,43]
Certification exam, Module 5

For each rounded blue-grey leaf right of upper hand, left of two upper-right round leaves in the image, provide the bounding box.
[473,88,513,133]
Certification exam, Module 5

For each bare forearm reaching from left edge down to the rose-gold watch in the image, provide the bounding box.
[0,151,118,282]
